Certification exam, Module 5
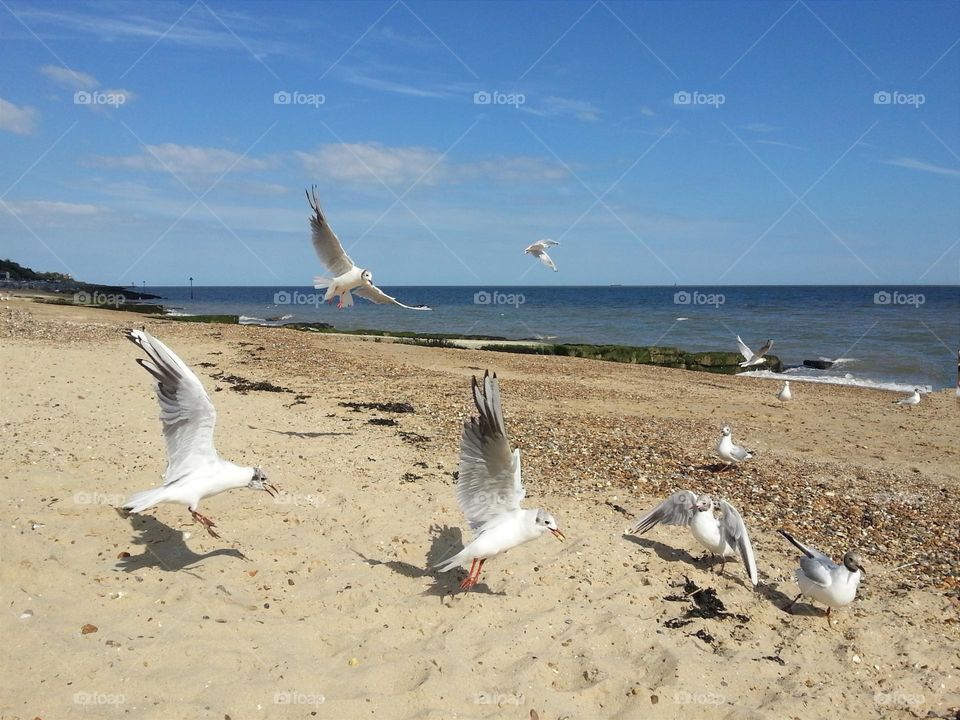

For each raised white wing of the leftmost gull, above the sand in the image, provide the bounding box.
[126,330,217,485]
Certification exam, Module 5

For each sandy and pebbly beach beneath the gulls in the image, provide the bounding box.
[0,298,960,720]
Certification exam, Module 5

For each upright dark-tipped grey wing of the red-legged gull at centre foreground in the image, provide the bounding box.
[457,372,524,530]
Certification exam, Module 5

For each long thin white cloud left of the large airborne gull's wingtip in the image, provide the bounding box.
[95,143,276,177]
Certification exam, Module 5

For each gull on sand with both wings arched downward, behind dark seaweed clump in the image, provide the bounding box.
[627,490,757,585]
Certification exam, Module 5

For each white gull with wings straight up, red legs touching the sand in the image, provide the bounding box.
[435,371,566,590]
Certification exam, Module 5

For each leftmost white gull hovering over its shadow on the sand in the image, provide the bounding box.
[122,330,277,538]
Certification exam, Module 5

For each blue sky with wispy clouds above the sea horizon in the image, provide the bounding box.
[0,0,960,286]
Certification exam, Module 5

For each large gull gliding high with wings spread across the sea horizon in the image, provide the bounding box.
[307,186,430,310]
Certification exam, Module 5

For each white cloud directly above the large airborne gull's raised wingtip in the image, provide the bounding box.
[294,143,444,185]
